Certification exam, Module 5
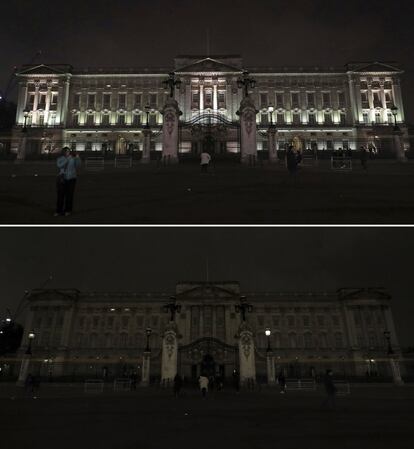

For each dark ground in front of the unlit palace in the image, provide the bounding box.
[0,386,414,449]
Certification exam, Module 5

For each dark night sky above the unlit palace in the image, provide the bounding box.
[0,228,414,345]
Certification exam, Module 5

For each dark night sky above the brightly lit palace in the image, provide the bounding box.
[0,0,414,121]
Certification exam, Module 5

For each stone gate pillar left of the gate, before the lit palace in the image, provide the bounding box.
[162,98,181,164]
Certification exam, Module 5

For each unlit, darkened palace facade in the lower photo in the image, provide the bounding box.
[17,282,399,380]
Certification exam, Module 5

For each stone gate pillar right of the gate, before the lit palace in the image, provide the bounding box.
[238,96,258,164]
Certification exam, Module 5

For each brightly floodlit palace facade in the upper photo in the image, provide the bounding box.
[12,56,408,157]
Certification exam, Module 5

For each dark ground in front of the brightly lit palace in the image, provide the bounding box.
[0,161,414,224]
